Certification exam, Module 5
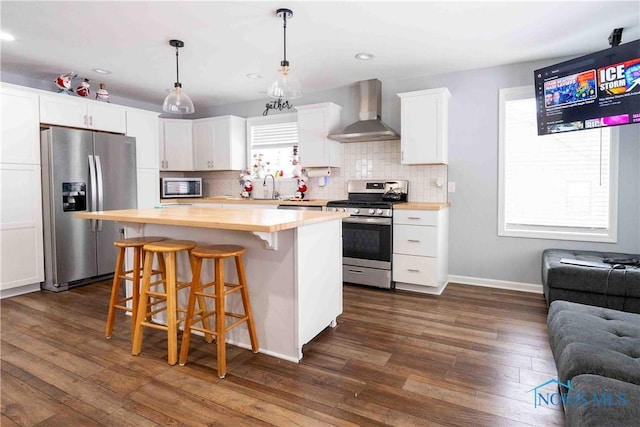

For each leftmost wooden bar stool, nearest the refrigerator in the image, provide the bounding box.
[104,237,164,338]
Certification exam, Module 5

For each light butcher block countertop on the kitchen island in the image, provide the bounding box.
[76,205,349,233]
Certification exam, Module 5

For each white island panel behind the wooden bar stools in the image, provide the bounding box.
[127,224,302,362]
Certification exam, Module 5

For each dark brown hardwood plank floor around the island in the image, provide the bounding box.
[0,282,564,427]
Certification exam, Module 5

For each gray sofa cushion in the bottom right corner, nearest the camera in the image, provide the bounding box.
[564,374,640,427]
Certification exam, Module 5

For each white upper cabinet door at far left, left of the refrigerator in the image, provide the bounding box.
[0,84,40,165]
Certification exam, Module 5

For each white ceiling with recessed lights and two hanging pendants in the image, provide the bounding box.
[0,0,640,110]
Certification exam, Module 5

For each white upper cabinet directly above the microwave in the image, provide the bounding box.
[160,119,193,171]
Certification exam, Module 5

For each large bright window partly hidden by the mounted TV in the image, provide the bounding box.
[498,87,618,242]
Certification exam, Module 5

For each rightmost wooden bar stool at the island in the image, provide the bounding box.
[180,245,258,378]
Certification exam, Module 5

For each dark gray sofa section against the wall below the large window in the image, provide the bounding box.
[542,249,640,313]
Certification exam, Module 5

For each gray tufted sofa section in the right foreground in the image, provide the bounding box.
[547,301,640,427]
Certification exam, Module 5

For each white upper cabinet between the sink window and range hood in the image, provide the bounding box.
[296,102,342,168]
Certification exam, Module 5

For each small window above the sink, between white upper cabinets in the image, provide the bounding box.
[247,113,298,178]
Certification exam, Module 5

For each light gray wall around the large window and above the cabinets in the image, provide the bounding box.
[207,58,640,284]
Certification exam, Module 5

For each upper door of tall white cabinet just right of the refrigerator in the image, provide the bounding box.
[127,108,160,169]
